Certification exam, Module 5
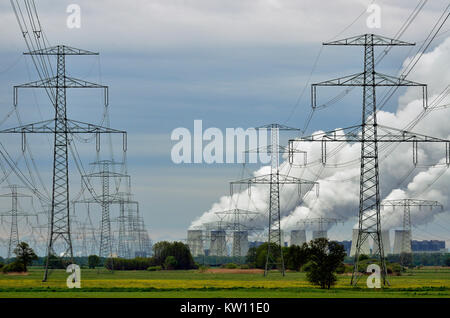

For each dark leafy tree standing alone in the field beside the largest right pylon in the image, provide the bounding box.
[306,238,346,289]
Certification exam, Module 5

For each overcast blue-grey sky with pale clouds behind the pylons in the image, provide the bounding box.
[0,0,450,253]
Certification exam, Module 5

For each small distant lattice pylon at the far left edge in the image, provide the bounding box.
[0,184,35,259]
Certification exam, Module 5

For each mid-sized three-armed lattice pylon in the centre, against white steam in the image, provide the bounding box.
[230,124,318,276]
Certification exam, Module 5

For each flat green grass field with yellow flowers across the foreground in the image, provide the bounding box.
[0,268,450,298]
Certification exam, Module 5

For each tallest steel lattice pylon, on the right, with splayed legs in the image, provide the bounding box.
[296,34,450,286]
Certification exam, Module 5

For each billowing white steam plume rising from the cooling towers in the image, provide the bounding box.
[192,38,450,236]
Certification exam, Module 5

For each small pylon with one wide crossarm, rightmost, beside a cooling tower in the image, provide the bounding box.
[382,199,444,265]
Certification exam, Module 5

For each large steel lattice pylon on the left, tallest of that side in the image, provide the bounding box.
[0,45,126,281]
